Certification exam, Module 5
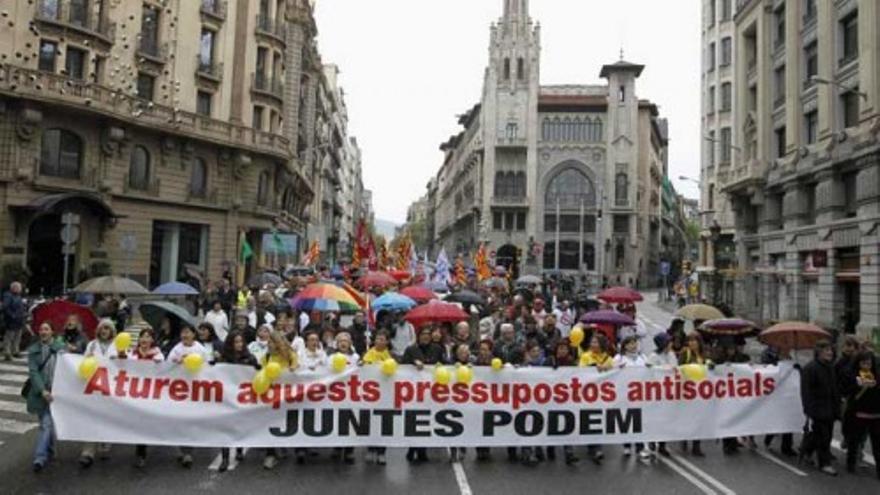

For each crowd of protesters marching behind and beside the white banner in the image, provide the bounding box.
[3,270,880,478]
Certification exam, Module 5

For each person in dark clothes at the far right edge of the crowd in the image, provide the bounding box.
[843,351,880,479]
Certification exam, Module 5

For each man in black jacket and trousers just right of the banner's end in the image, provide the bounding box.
[800,340,840,476]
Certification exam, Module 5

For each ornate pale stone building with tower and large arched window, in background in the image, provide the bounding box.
[427,0,667,286]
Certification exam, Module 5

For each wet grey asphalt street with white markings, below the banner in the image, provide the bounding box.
[0,292,880,495]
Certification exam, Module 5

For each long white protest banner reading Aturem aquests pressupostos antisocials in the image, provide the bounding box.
[52,355,804,447]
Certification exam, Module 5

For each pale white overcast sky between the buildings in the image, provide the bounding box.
[316,0,700,223]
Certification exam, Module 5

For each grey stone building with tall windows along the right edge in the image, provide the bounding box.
[719,0,880,336]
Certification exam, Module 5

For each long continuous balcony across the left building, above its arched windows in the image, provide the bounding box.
[0,64,291,160]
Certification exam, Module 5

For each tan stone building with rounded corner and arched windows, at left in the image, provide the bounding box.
[0,0,360,294]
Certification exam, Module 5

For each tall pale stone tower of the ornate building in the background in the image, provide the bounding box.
[480,0,540,265]
